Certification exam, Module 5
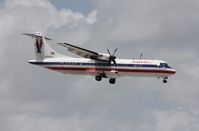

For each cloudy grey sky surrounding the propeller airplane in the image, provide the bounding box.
[0,0,199,131]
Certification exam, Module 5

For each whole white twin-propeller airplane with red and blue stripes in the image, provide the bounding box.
[24,32,176,84]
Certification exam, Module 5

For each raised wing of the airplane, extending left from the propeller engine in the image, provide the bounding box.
[57,43,104,61]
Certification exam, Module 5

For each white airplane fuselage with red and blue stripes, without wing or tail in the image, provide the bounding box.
[29,57,176,78]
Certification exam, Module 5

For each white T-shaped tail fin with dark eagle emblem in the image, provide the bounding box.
[23,32,58,60]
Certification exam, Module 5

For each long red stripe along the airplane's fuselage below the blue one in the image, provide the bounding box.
[46,67,176,74]
